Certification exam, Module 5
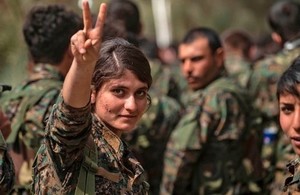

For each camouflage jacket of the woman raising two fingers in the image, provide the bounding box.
[32,96,149,195]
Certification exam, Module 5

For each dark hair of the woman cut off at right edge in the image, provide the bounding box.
[276,57,300,100]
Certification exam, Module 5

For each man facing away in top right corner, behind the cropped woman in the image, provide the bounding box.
[250,0,300,194]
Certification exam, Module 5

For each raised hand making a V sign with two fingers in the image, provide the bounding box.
[71,0,106,65]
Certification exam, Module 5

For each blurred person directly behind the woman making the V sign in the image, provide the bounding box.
[106,0,182,194]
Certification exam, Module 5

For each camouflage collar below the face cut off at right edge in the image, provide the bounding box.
[282,157,300,195]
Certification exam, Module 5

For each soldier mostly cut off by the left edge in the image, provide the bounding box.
[0,84,15,194]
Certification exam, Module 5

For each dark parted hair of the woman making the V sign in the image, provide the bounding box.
[92,38,152,91]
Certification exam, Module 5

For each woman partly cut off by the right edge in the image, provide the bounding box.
[277,58,300,194]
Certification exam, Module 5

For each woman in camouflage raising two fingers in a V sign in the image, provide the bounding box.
[32,1,152,194]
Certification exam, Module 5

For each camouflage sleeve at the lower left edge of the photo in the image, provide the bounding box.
[0,130,15,194]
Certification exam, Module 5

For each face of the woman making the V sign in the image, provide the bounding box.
[91,70,148,136]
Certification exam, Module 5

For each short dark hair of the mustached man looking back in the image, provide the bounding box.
[181,27,222,54]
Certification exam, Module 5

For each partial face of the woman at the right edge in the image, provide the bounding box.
[279,91,300,155]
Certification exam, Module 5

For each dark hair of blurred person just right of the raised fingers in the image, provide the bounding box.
[106,0,141,35]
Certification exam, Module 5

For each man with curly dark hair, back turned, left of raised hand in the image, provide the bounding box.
[0,4,82,193]
